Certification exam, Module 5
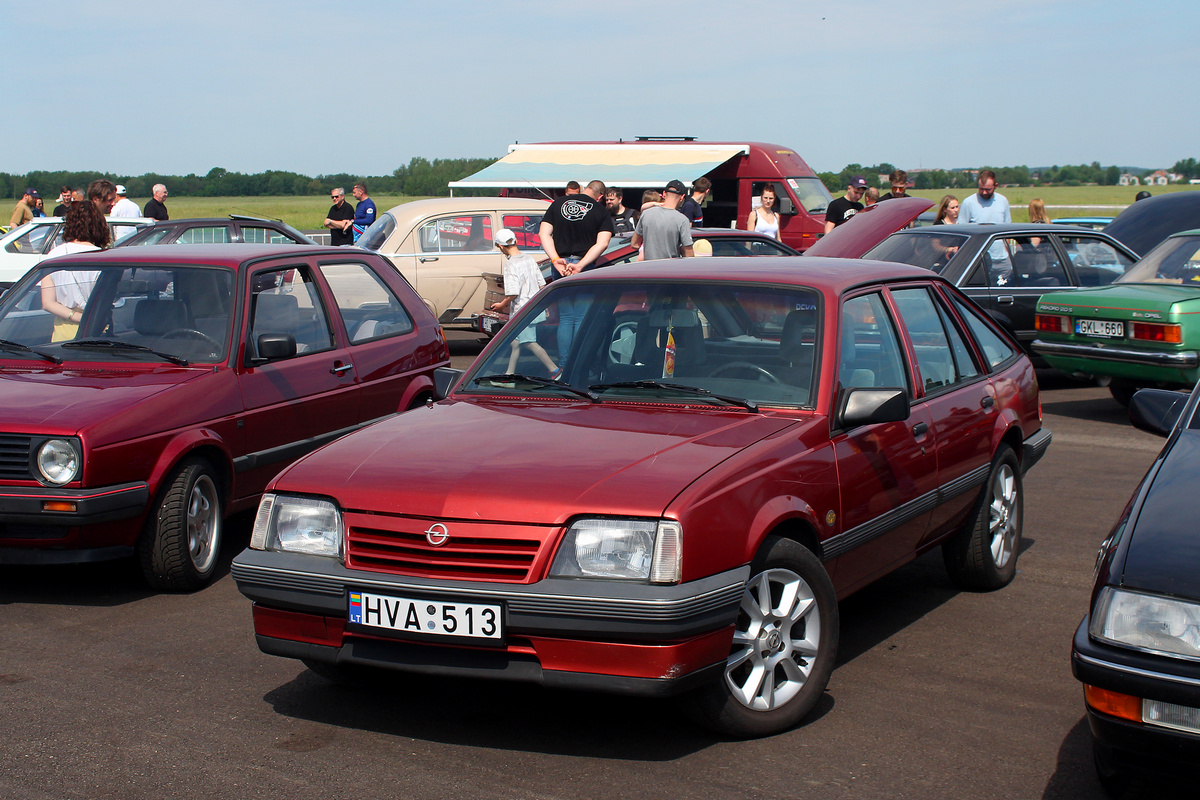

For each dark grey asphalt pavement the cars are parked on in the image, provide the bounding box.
[0,350,1180,800]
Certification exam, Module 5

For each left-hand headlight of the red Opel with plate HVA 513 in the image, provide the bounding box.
[250,493,343,558]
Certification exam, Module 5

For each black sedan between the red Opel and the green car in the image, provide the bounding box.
[863,223,1138,351]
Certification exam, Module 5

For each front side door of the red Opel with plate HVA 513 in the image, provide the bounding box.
[826,290,938,588]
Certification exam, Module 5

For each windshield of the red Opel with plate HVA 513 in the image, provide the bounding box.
[463,279,821,409]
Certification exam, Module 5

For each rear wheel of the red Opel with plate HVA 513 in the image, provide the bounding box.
[942,445,1025,591]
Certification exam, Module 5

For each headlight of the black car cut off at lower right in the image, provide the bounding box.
[1087,587,1200,661]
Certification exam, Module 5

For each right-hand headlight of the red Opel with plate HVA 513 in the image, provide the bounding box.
[550,519,682,583]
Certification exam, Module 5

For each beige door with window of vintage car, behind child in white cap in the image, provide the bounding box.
[406,211,504,324]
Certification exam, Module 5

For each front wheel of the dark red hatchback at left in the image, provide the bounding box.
[138,458,224,591]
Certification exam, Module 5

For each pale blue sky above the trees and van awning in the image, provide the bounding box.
[11,0,1200,175]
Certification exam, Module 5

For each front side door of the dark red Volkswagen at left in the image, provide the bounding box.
[235,261,361,497]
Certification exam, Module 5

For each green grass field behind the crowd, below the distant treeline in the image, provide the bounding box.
[114,185,1200,230]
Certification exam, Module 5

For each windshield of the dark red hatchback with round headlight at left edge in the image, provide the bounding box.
[0,261,234,363]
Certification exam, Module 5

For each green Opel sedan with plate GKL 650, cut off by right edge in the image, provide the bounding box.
[1033,230,1200,405]
